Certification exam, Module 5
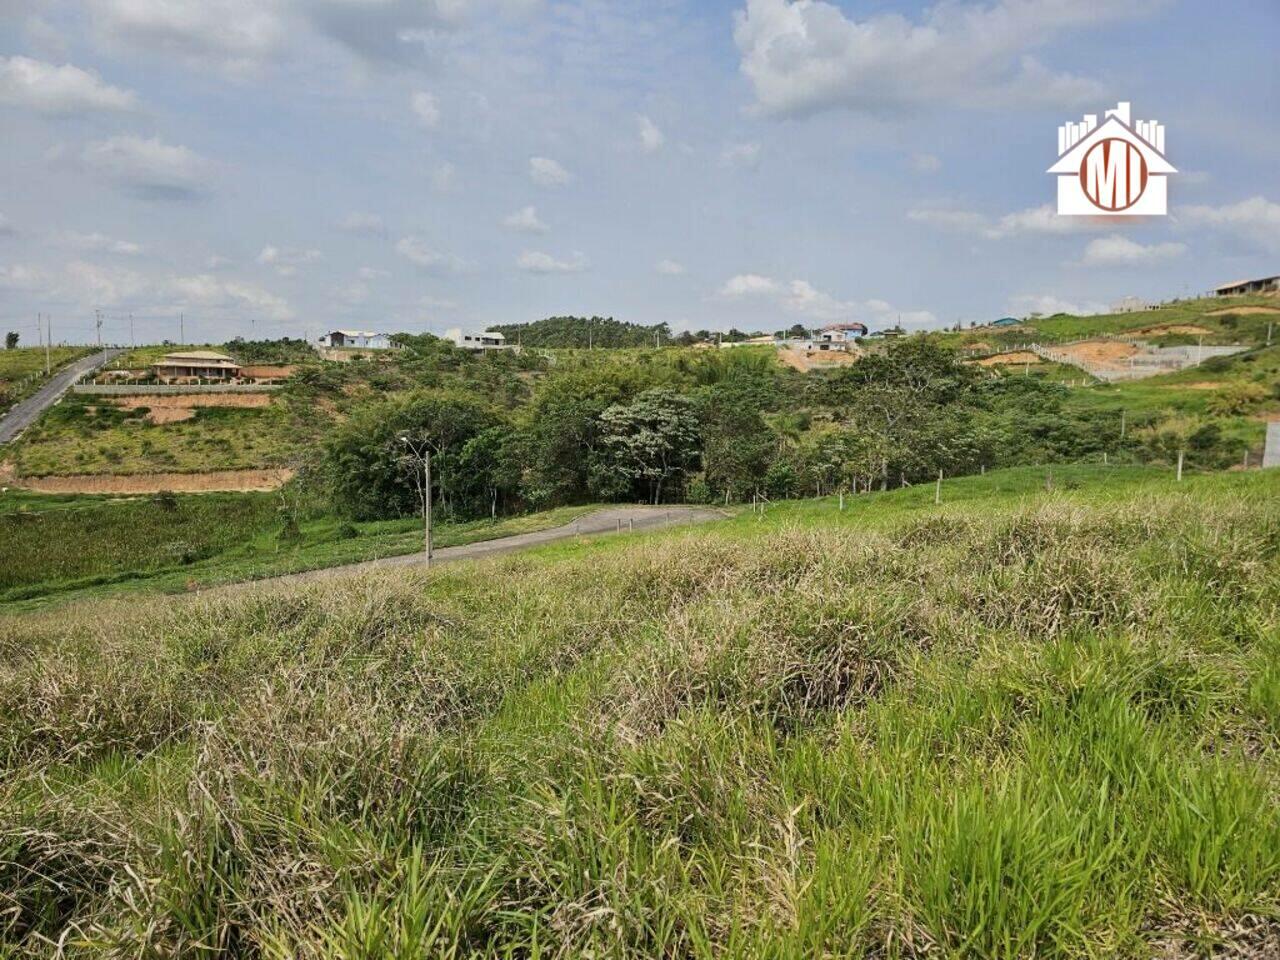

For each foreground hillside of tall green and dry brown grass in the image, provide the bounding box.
[0,470,1280,957]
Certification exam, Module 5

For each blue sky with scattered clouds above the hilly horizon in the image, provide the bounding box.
[0,0,1280,344]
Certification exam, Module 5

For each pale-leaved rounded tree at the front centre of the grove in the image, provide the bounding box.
[600,387,699,503]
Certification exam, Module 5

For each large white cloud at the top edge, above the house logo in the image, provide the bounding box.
[733,0,1161,115]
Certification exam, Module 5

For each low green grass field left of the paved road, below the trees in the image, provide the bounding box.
[0,490,609,611]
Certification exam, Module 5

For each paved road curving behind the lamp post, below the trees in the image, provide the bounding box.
[241,507,728,586]
